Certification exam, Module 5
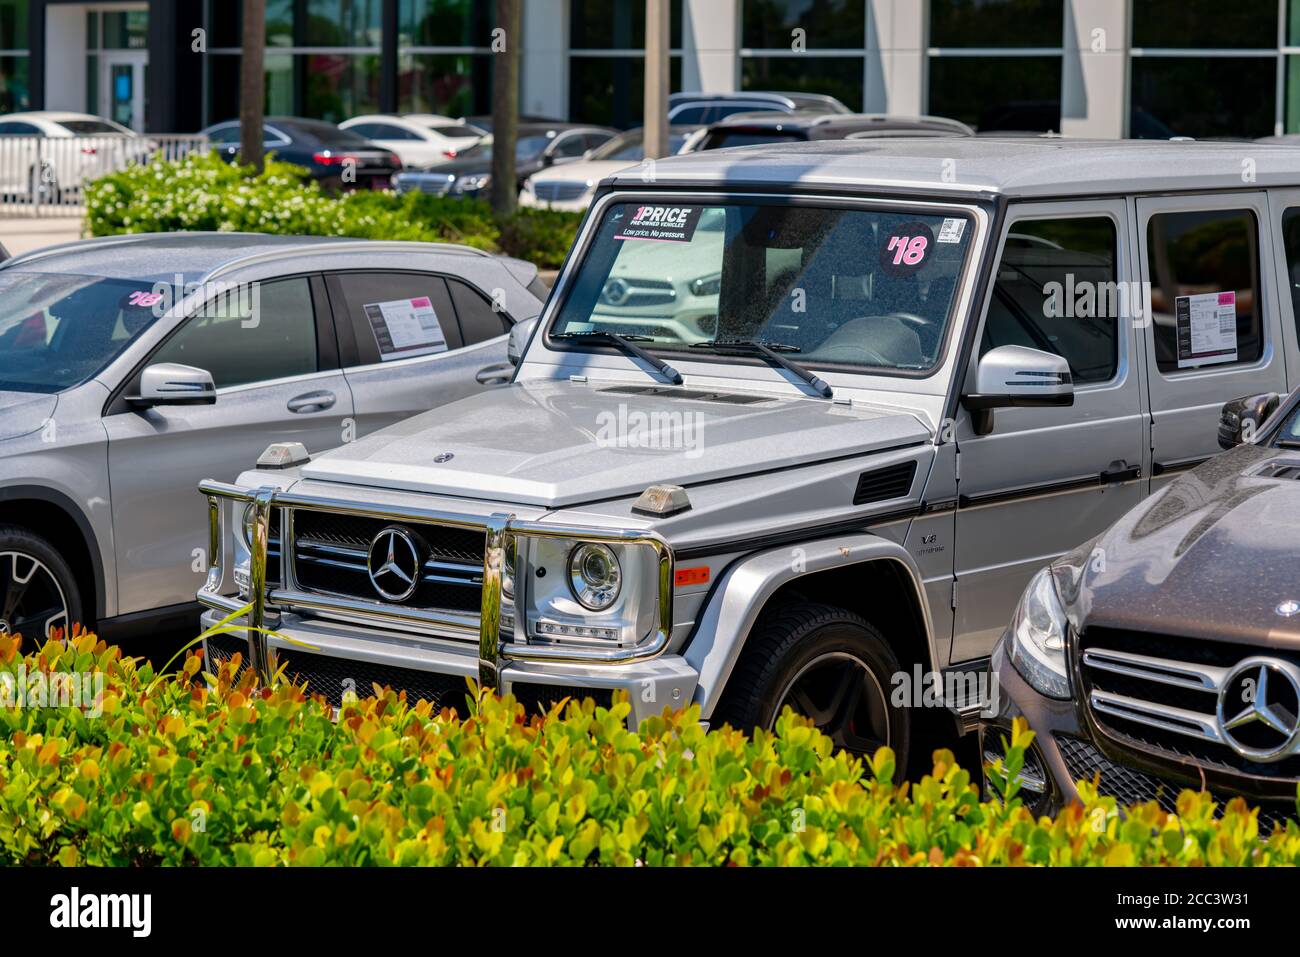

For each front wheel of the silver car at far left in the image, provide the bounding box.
[0,525,85,642]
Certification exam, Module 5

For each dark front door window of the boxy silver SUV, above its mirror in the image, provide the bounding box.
[980,216,1125,384]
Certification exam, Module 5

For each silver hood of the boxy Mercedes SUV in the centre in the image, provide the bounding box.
[302,381,931,507]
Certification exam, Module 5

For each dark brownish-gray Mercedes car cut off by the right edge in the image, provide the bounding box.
[982,393,1300,827]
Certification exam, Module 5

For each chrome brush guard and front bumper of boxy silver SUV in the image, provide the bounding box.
[198,481,698,724]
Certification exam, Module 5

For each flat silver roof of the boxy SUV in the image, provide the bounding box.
[606,137,1300,198]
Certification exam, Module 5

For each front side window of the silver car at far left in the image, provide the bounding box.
[150,277,320,389]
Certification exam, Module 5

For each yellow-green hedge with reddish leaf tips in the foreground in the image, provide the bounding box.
[0,635,1300,865]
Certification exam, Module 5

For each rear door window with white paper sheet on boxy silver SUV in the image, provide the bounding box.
[1147,209,1264,372]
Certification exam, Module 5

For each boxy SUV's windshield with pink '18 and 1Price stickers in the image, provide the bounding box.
[551,203,974,372]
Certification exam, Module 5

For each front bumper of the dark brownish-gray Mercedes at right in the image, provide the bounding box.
[980,635,1295,831]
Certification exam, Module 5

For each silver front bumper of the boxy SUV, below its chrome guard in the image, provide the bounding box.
[203,611,699,727]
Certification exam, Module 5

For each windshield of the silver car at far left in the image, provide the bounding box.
[0,270,169,393]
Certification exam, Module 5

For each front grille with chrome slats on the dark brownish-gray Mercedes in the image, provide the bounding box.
[1079,628,1300,779]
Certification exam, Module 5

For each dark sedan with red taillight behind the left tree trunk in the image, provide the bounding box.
[203,116,402,190]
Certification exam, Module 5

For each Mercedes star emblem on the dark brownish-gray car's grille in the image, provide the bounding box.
[1216,657,1300,762]
